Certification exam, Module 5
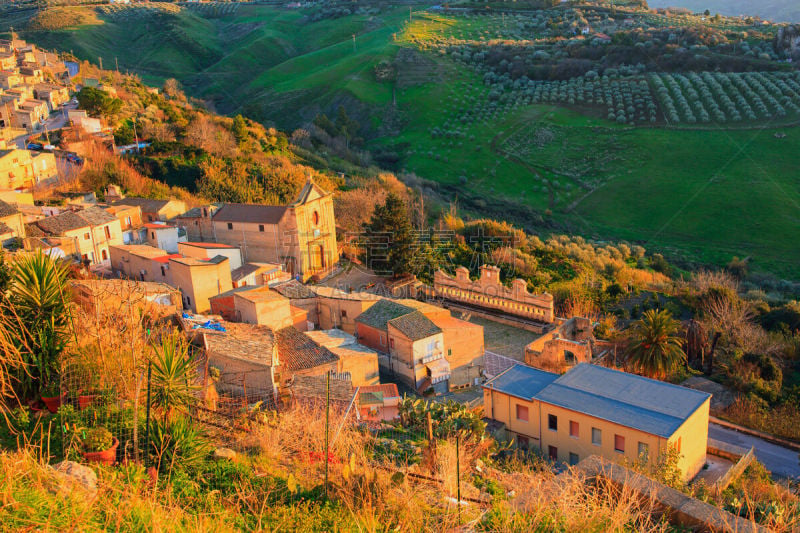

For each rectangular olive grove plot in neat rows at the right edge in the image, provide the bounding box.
[650,72,800,124]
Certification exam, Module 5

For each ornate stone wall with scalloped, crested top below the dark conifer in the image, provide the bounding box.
[433,265,555,324]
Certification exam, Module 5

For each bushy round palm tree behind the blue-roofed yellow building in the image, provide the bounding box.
[625,309,686,378]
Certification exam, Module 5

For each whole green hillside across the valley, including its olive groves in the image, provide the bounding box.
[9,3,800,277]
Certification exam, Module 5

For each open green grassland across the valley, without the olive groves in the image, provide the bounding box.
[9,5,800,278]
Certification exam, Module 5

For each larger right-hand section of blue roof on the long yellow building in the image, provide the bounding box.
[536,363,711,438]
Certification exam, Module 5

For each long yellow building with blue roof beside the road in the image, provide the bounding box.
[483,363,711,479]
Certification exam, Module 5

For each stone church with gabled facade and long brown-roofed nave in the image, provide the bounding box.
[177,179,339,281]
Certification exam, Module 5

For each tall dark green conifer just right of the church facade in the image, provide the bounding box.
[364,193,414,276]
